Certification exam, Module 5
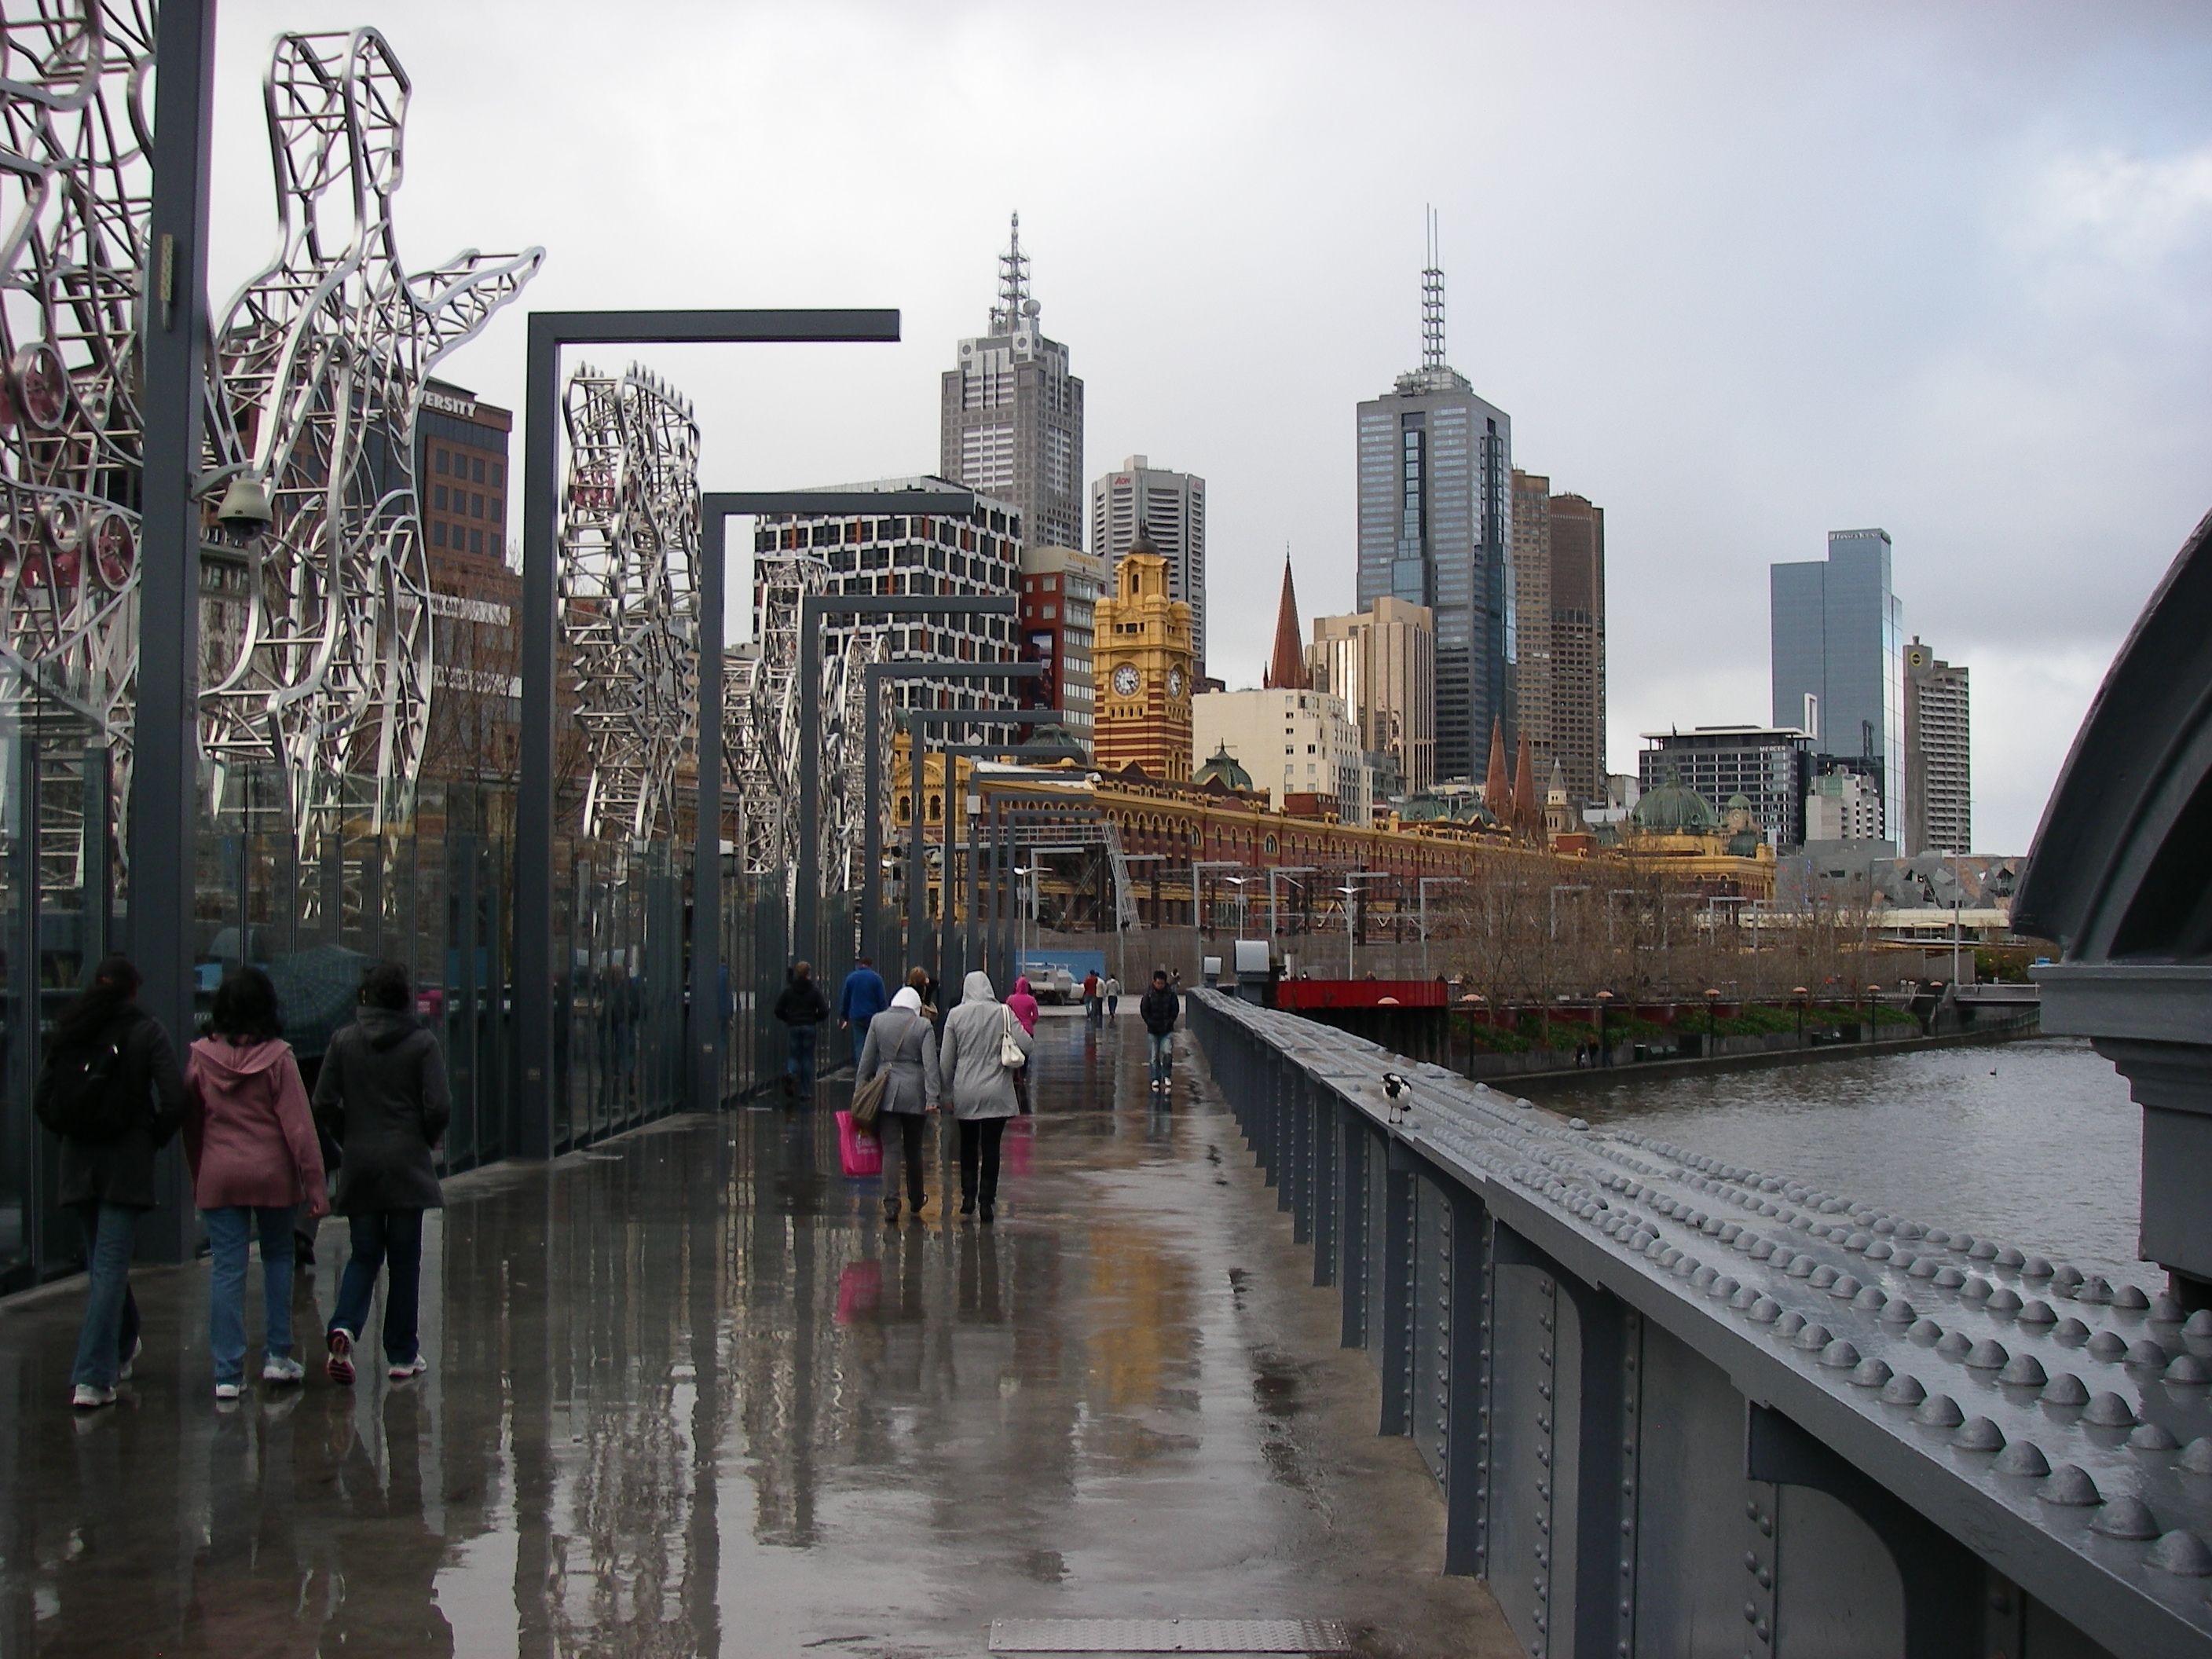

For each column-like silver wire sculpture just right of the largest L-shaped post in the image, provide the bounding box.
[559,365,699,843]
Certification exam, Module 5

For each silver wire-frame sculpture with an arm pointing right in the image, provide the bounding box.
[201,29,544,843]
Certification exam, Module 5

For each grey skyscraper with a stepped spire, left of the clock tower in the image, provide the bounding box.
[938,214,1084,547]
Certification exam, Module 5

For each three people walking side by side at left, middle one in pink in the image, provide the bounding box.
[33,956,449,1409]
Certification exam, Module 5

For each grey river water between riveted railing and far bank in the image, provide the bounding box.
[1529,1038,2166,1294]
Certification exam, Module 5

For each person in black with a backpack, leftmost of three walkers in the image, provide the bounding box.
[31,956,184,1409]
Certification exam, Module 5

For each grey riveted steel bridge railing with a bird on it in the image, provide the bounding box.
[1185,991,2212,1659]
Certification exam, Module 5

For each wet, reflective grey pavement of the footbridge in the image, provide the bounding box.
[0,1013,1518,1659]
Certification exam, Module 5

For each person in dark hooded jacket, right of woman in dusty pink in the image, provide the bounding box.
[314,962,453,1385]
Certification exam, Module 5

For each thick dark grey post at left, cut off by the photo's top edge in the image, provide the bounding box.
[130,0,214,1261]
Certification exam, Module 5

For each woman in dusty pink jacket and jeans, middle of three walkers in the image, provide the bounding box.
[184,967,330,1401]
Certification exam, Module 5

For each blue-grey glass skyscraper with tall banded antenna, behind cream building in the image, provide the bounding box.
[1358,229,1515,778]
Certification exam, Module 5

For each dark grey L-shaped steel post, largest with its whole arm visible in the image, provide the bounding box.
[519,318,898,1157]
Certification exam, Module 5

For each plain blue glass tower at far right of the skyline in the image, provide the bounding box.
[1770,529,1905,840]
